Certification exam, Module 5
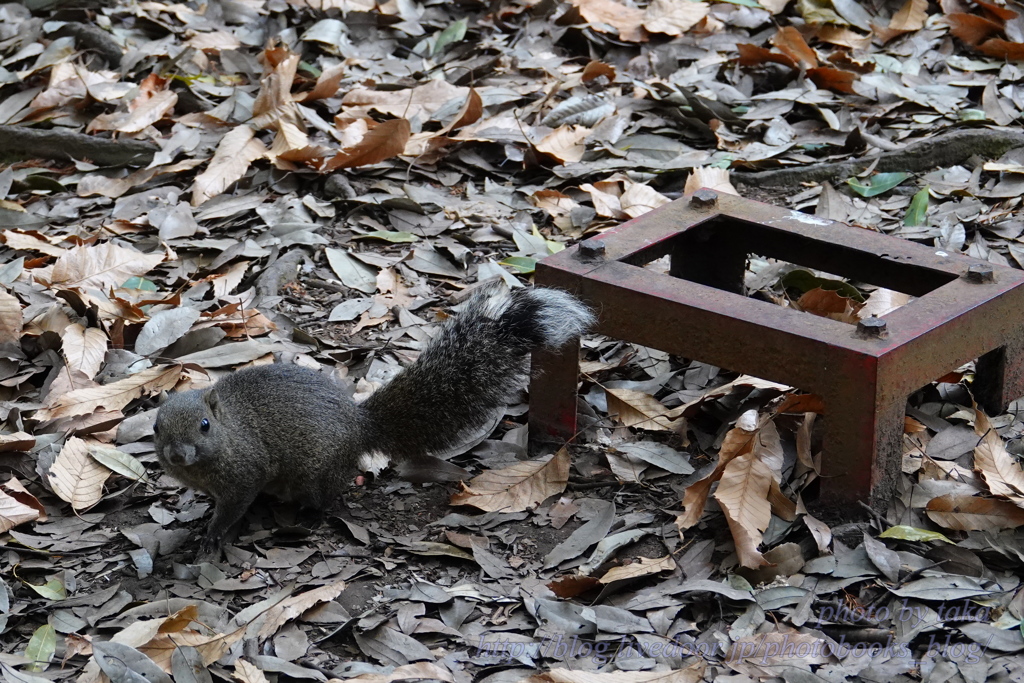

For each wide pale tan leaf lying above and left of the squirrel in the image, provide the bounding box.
[35,242,165,290]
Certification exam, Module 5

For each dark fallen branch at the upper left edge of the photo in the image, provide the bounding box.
[0,126,160,166]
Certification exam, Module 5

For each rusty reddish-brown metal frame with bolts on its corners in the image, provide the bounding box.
[529,189,1024,509]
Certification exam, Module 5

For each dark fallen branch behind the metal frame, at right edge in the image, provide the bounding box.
[731,128,1024,187]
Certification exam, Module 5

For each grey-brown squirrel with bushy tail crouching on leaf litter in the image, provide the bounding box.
[153,288,594,558]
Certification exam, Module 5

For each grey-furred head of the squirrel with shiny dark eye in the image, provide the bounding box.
[153,388,224,470]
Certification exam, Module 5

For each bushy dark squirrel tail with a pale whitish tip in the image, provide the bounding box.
[362,288,594,480]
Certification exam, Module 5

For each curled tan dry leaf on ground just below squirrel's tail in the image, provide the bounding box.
[451,447,569,512]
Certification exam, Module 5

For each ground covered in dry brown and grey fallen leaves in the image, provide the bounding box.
[0,0,1024,683]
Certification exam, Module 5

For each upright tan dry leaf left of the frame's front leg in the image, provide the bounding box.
[715,452,773,569]
